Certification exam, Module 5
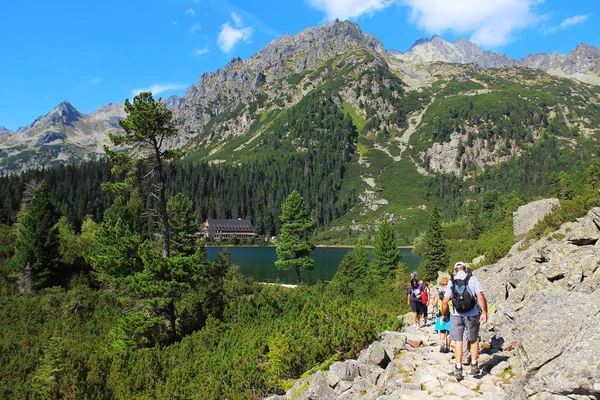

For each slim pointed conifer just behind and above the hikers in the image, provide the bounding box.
[418,206,450,282]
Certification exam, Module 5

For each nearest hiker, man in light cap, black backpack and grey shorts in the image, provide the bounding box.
[442,261,487,381]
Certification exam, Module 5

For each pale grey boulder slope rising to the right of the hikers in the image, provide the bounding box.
[474,208,600,399]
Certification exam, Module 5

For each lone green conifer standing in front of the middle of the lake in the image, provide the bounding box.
[275,190,315,284]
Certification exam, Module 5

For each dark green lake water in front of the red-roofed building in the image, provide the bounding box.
[206,247,421,285]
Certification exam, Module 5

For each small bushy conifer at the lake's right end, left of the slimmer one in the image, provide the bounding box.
[372,221,401,281]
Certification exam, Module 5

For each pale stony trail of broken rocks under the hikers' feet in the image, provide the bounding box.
[269,314,521,400]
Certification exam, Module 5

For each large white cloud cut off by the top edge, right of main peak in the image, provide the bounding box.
[402,0,544,47]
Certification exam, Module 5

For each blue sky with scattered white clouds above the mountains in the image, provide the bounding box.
[0,0,600,130]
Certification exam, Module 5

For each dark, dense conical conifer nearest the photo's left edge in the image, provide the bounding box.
[11,182,59,291]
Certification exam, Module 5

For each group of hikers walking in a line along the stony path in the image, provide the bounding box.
[407,262,487,381]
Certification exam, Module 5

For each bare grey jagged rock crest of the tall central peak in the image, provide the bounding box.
[173,21,385,144]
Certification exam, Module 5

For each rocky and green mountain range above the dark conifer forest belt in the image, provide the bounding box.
[0,21,600,242]
